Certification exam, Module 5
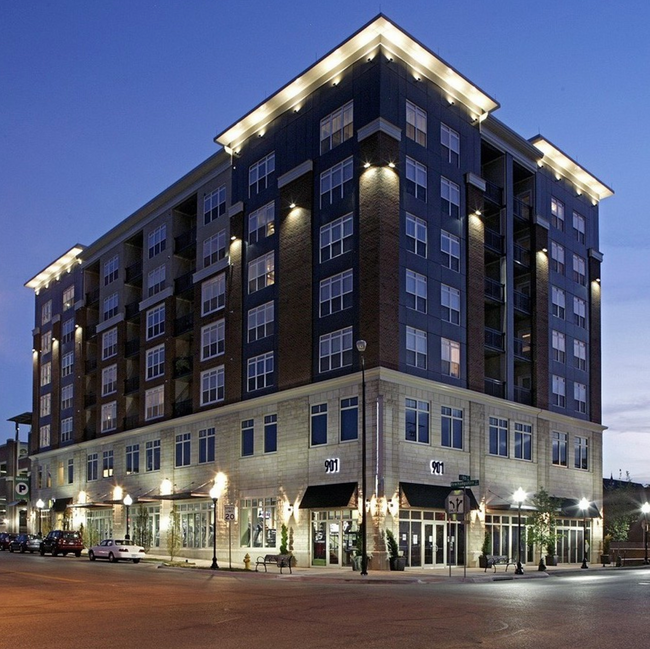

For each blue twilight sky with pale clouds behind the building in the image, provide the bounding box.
[0,0,650,483]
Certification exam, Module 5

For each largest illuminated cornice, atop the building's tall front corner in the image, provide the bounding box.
[214,14,499,153]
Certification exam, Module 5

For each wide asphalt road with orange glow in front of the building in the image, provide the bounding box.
[0,553,650,649]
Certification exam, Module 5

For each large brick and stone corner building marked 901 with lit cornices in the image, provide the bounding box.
[27,16,612,569]
